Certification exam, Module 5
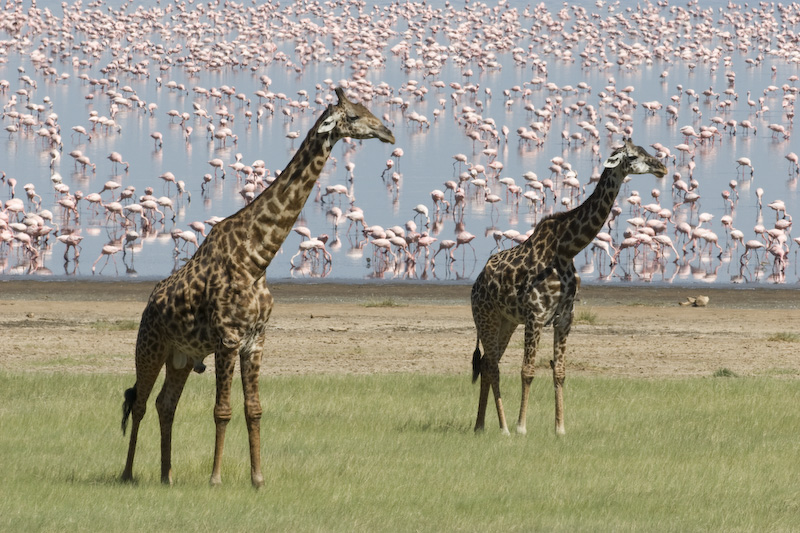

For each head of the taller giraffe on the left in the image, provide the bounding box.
[315,87,394,144]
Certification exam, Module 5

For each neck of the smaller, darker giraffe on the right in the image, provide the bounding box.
[556,165,625,258]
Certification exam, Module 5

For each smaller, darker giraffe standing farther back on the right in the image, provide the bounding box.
[471,139,667,435]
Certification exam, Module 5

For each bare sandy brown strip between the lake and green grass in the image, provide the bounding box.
[0,281,800,378]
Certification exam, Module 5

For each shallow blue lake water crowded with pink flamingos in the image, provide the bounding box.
[0,0,800,283]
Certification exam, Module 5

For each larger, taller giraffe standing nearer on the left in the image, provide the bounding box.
[122,88,394,487]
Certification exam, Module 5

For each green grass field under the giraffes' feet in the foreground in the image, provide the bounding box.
[0,372,800,532]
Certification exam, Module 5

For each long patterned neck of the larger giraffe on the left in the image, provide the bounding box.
[223,107,338,278]
